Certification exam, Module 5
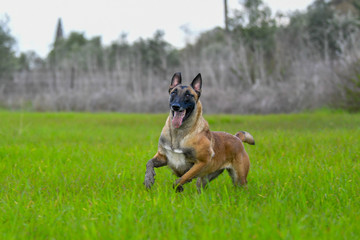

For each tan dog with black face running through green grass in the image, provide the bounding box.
[144,73,255,193]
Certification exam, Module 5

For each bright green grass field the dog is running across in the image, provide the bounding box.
[0,111,360,239]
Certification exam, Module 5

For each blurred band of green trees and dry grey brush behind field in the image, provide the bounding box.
[0,0,360,113]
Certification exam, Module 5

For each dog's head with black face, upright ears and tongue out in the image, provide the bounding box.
[169,73,202,128]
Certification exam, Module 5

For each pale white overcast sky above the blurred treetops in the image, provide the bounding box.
[0,0,313,57]
